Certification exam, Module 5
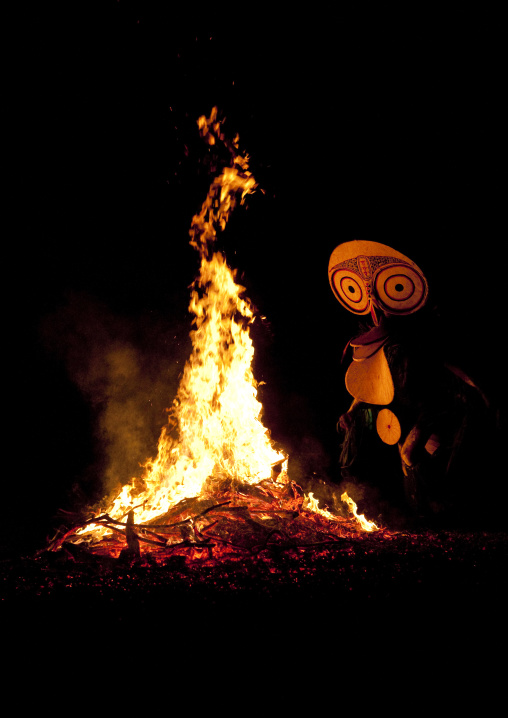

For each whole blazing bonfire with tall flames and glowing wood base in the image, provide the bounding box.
[48,108,378,559]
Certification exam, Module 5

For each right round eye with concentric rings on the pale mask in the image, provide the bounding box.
[374,264,427,314]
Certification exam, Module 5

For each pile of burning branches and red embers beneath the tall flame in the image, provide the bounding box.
[48,480,388,562]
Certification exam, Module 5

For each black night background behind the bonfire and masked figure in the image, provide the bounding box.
[4,1,505,546]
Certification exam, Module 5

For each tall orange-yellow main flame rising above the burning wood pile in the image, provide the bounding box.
[81,108,287,537]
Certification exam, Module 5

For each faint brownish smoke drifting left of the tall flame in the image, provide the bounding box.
[41,294,190,500]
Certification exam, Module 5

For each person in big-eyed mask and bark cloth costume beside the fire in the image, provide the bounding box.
[328,240,488,515]
